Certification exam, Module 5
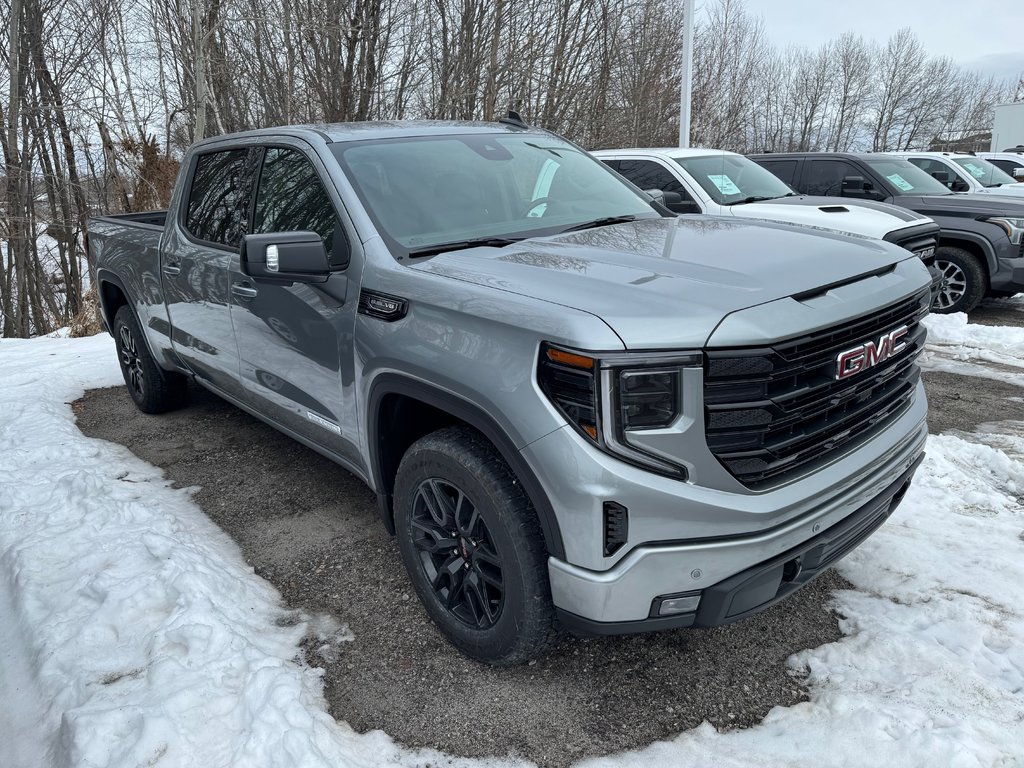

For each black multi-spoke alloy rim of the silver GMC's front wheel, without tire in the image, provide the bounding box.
[412,477,505,630]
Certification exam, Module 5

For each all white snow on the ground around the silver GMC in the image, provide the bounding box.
[0,333,1024,768]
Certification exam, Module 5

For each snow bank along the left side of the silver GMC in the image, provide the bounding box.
[0,336,512,768]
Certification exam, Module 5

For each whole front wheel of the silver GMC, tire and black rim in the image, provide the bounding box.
[394,427,554,667]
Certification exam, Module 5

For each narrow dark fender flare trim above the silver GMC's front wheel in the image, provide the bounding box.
[367,373,565,559]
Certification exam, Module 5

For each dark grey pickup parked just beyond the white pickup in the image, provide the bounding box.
[751,153,1024,312]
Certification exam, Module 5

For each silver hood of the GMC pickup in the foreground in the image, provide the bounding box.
[412,216,912,349]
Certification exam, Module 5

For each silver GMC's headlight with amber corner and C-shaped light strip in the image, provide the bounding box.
[538,343,703,478]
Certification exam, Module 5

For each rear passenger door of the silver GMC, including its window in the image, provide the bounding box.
[161,147,259,398]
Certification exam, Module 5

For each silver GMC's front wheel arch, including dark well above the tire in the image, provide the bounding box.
[367,374,565,558]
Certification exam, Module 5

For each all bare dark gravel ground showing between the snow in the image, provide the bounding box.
[74,302,1024,766]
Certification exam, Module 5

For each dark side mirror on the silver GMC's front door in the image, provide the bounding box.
[242,231,331,283]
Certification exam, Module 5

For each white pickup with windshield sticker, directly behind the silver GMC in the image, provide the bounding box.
[592,148,939,265]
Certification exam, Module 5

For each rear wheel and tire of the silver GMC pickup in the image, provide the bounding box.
[114,304,188,414]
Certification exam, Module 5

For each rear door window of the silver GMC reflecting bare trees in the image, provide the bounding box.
[185,150,259,249]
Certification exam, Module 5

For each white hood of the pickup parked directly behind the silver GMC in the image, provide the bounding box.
[729,195,931,240]
